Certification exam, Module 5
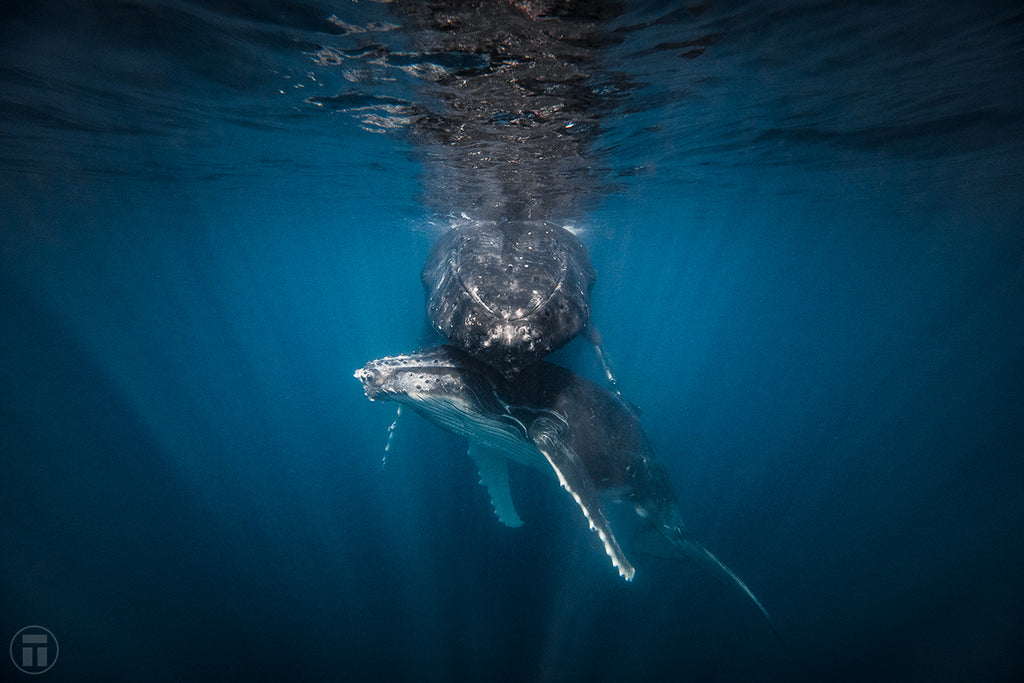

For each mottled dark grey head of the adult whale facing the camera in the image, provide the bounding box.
[422,220,595,379]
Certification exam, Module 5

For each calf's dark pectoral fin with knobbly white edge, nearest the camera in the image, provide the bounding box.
[530,420,636,581]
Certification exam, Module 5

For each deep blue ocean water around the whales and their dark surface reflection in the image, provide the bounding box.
[0,0,1024,681]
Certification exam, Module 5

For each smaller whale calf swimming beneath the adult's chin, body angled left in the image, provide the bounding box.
[355,346,778,637]
